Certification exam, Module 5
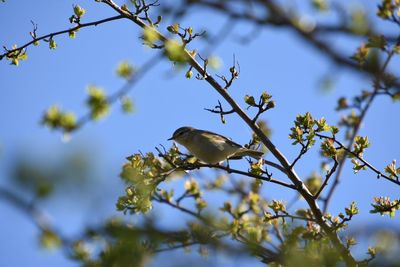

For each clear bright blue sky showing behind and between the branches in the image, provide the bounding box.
[0,0,400,266]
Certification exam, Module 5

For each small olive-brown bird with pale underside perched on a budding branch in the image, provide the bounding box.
[168,127,264,164]
